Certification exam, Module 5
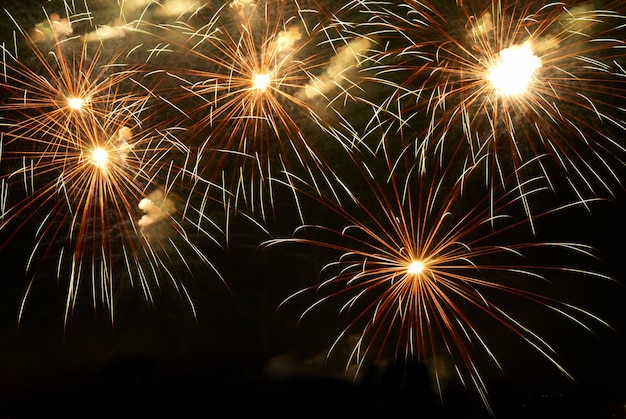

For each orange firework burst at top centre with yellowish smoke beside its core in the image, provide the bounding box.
[139,1,369,223]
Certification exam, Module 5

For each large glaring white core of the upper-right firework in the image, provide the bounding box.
[487,43,541,96]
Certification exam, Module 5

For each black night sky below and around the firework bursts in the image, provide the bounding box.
[0,0,626,418]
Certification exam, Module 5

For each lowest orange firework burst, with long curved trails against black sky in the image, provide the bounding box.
[270,149,608,416]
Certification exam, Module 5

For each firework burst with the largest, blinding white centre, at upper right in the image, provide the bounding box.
[358,0,626,215]
